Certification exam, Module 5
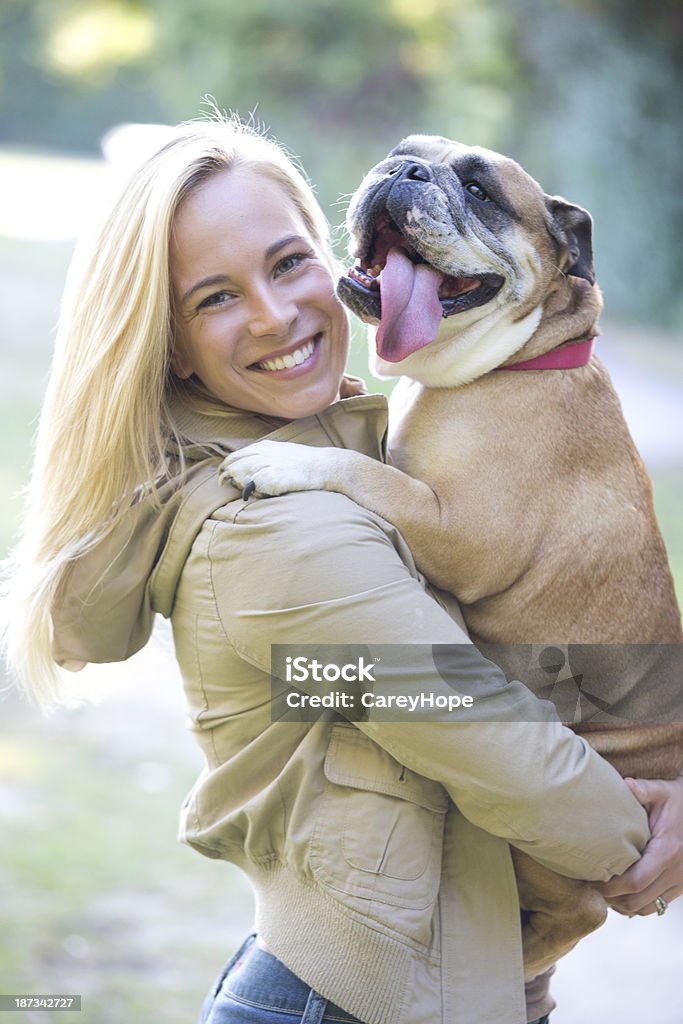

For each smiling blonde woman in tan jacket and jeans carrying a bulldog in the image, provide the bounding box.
[2,117,678,1024]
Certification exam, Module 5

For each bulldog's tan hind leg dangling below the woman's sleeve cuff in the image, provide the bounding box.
[512,848,607,981]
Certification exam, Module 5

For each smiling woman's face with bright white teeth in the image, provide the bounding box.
[170,167,348,420]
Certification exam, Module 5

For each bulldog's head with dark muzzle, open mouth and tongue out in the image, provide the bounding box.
[338,135,594,386]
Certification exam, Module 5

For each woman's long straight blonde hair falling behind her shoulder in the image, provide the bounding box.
[3,118,335,706]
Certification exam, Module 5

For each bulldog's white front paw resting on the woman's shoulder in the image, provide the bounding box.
[218,440,326,498]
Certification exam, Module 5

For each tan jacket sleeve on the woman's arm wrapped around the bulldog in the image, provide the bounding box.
[204,492,648,880]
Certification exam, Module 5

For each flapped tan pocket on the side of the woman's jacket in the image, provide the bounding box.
[311,725,449,924]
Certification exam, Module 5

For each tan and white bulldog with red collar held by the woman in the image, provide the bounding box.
[225,135,683,978]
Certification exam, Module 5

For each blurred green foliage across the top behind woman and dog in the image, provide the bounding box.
[0,0,683,327]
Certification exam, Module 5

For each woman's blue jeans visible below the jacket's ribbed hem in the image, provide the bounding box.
[200,935,548,1024]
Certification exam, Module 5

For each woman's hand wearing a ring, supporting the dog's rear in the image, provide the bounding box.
[597,775,683,916]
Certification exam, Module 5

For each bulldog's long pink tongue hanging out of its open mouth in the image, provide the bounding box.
[377,247,442,362]
